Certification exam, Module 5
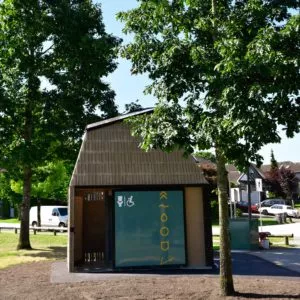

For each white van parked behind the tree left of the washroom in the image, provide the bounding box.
[29,206,68,227]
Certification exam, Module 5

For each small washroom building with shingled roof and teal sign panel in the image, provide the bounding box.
[68,109,213,272]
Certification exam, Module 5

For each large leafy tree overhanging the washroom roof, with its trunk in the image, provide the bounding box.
[119,0,300,295]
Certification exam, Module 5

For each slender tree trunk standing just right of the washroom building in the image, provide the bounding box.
[216,148,234,296]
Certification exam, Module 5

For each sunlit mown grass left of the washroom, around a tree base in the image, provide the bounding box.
[0,232,67,269]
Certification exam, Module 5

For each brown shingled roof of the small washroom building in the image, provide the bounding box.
[71,109,207,186]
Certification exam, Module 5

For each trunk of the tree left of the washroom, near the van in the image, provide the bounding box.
[17,166,32,250]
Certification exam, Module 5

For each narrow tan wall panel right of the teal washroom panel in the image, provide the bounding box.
[185,187,206,267]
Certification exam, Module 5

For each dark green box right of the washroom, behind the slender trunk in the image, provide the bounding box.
[229,218,259,250]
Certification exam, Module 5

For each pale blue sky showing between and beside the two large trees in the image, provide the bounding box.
[94,0,300,164]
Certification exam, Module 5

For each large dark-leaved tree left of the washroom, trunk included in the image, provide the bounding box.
[0,0,119,249]
